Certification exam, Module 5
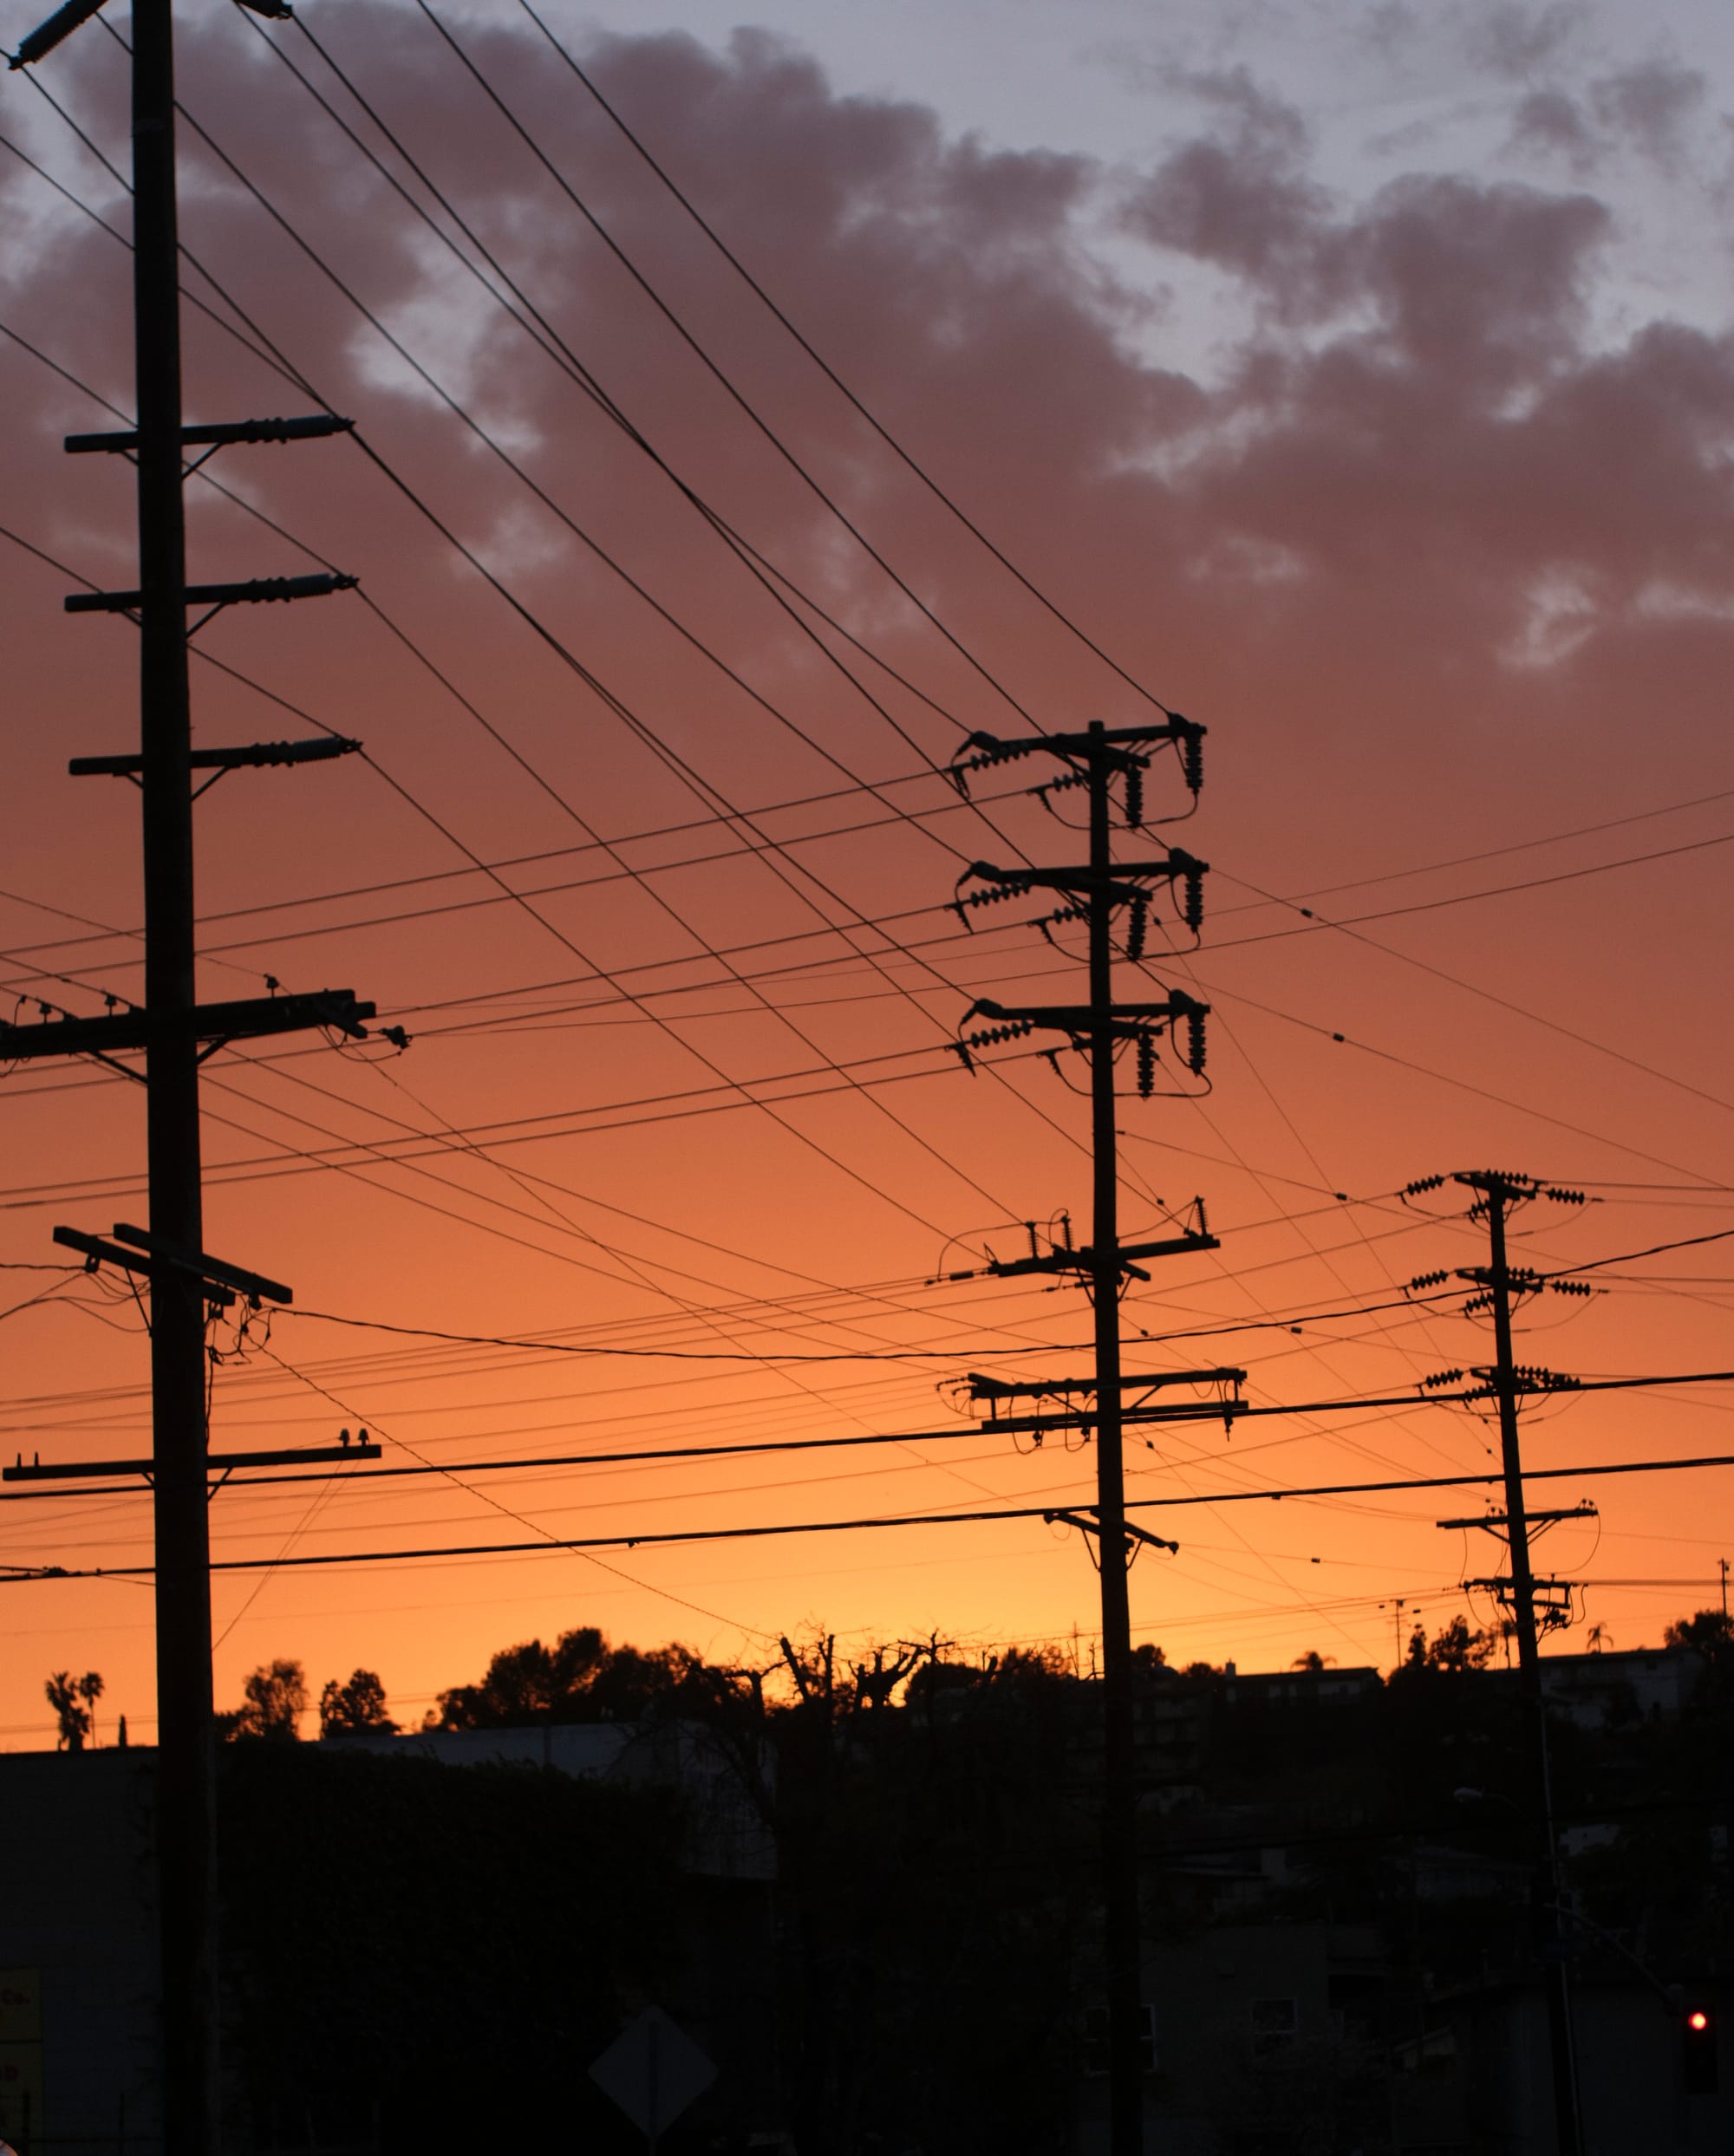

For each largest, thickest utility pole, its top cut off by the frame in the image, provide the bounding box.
[0,0,386,2156]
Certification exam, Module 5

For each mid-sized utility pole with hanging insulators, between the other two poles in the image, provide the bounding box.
[954,716,1216,2156]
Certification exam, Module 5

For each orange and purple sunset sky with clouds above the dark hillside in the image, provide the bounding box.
[0,0,1734,1749]
